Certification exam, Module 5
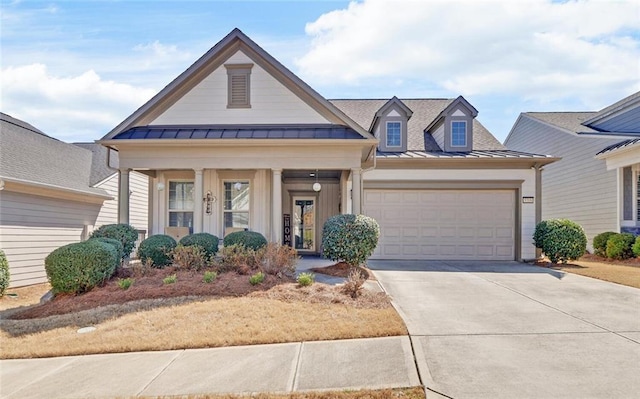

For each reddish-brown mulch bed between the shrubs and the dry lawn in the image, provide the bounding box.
[10,267,295,320]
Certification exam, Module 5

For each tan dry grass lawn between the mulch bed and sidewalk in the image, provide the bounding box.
[0,284,407,359]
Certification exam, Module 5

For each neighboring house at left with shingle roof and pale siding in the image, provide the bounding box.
[0,113,148,287]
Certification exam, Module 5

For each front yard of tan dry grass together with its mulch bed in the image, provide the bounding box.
[0,268,407,359]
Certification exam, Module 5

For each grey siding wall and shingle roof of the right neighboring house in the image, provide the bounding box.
[505,116,620,250]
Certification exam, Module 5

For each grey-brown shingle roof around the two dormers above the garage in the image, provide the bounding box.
[329,99,505,151]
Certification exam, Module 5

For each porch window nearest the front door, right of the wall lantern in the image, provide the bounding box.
[223,180,251,236]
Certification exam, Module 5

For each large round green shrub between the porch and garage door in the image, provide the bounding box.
[322,214,380,266]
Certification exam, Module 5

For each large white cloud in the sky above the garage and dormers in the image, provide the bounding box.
[296,0,640,108]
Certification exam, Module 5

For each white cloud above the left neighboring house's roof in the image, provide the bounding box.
[0,64,156,141]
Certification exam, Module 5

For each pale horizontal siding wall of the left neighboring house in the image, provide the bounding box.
[0,190,100,287]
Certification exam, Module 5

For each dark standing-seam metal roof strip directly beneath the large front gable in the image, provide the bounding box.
[113,124,364,140]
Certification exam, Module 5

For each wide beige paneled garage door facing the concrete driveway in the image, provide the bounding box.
[364,189,516,260]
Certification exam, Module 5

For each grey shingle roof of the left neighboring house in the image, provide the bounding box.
[0,113,107,196]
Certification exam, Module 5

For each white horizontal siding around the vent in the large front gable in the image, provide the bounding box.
[151,51,328,125]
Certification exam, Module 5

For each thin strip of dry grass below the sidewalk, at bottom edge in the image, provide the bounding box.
[136,387,425,399]
